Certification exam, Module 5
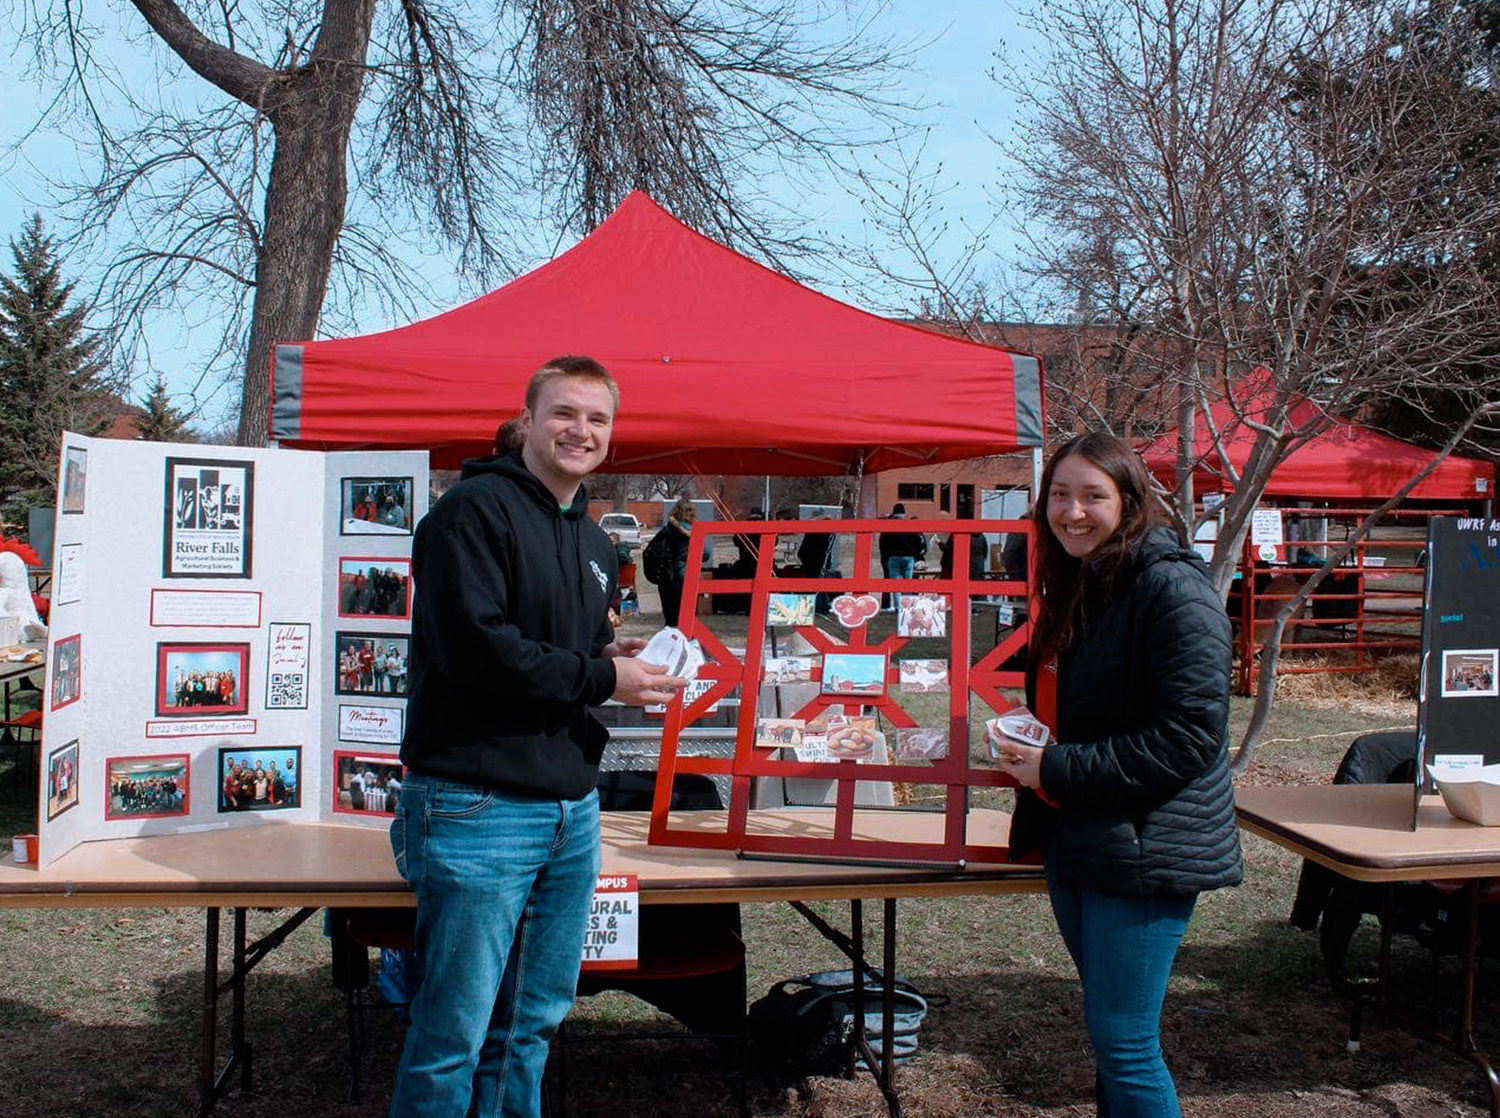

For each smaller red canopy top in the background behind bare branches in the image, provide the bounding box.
[1140,401,1494,501]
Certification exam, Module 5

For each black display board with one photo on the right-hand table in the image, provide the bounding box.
[1418,516,1500,810]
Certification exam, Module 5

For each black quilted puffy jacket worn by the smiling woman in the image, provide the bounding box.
[1011,528,1241,896]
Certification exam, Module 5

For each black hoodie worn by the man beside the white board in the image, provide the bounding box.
[401,453,617,798]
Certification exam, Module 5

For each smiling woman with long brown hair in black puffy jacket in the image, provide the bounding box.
[999,434,1241,1118]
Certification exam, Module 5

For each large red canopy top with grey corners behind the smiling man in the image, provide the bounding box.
[270,192,1043,474]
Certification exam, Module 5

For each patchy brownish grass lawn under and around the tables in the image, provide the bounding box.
[0,642,1500,1118]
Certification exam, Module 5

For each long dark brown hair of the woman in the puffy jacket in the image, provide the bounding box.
[1031,431,1161,660]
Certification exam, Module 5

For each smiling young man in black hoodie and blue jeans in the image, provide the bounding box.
[392,357,684,1118]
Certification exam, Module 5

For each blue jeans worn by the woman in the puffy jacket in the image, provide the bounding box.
[1047,857,1197,1118]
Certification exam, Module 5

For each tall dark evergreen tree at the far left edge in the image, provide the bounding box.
[0,213,110,524]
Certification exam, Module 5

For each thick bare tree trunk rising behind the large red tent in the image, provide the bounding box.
[237,0,375,446]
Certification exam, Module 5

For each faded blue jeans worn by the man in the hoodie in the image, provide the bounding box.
[390,773,599,1118]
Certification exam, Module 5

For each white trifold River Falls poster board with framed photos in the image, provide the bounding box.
[38,434,428,866]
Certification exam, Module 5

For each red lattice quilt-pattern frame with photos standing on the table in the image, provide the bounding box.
[650,519,1031,864]
